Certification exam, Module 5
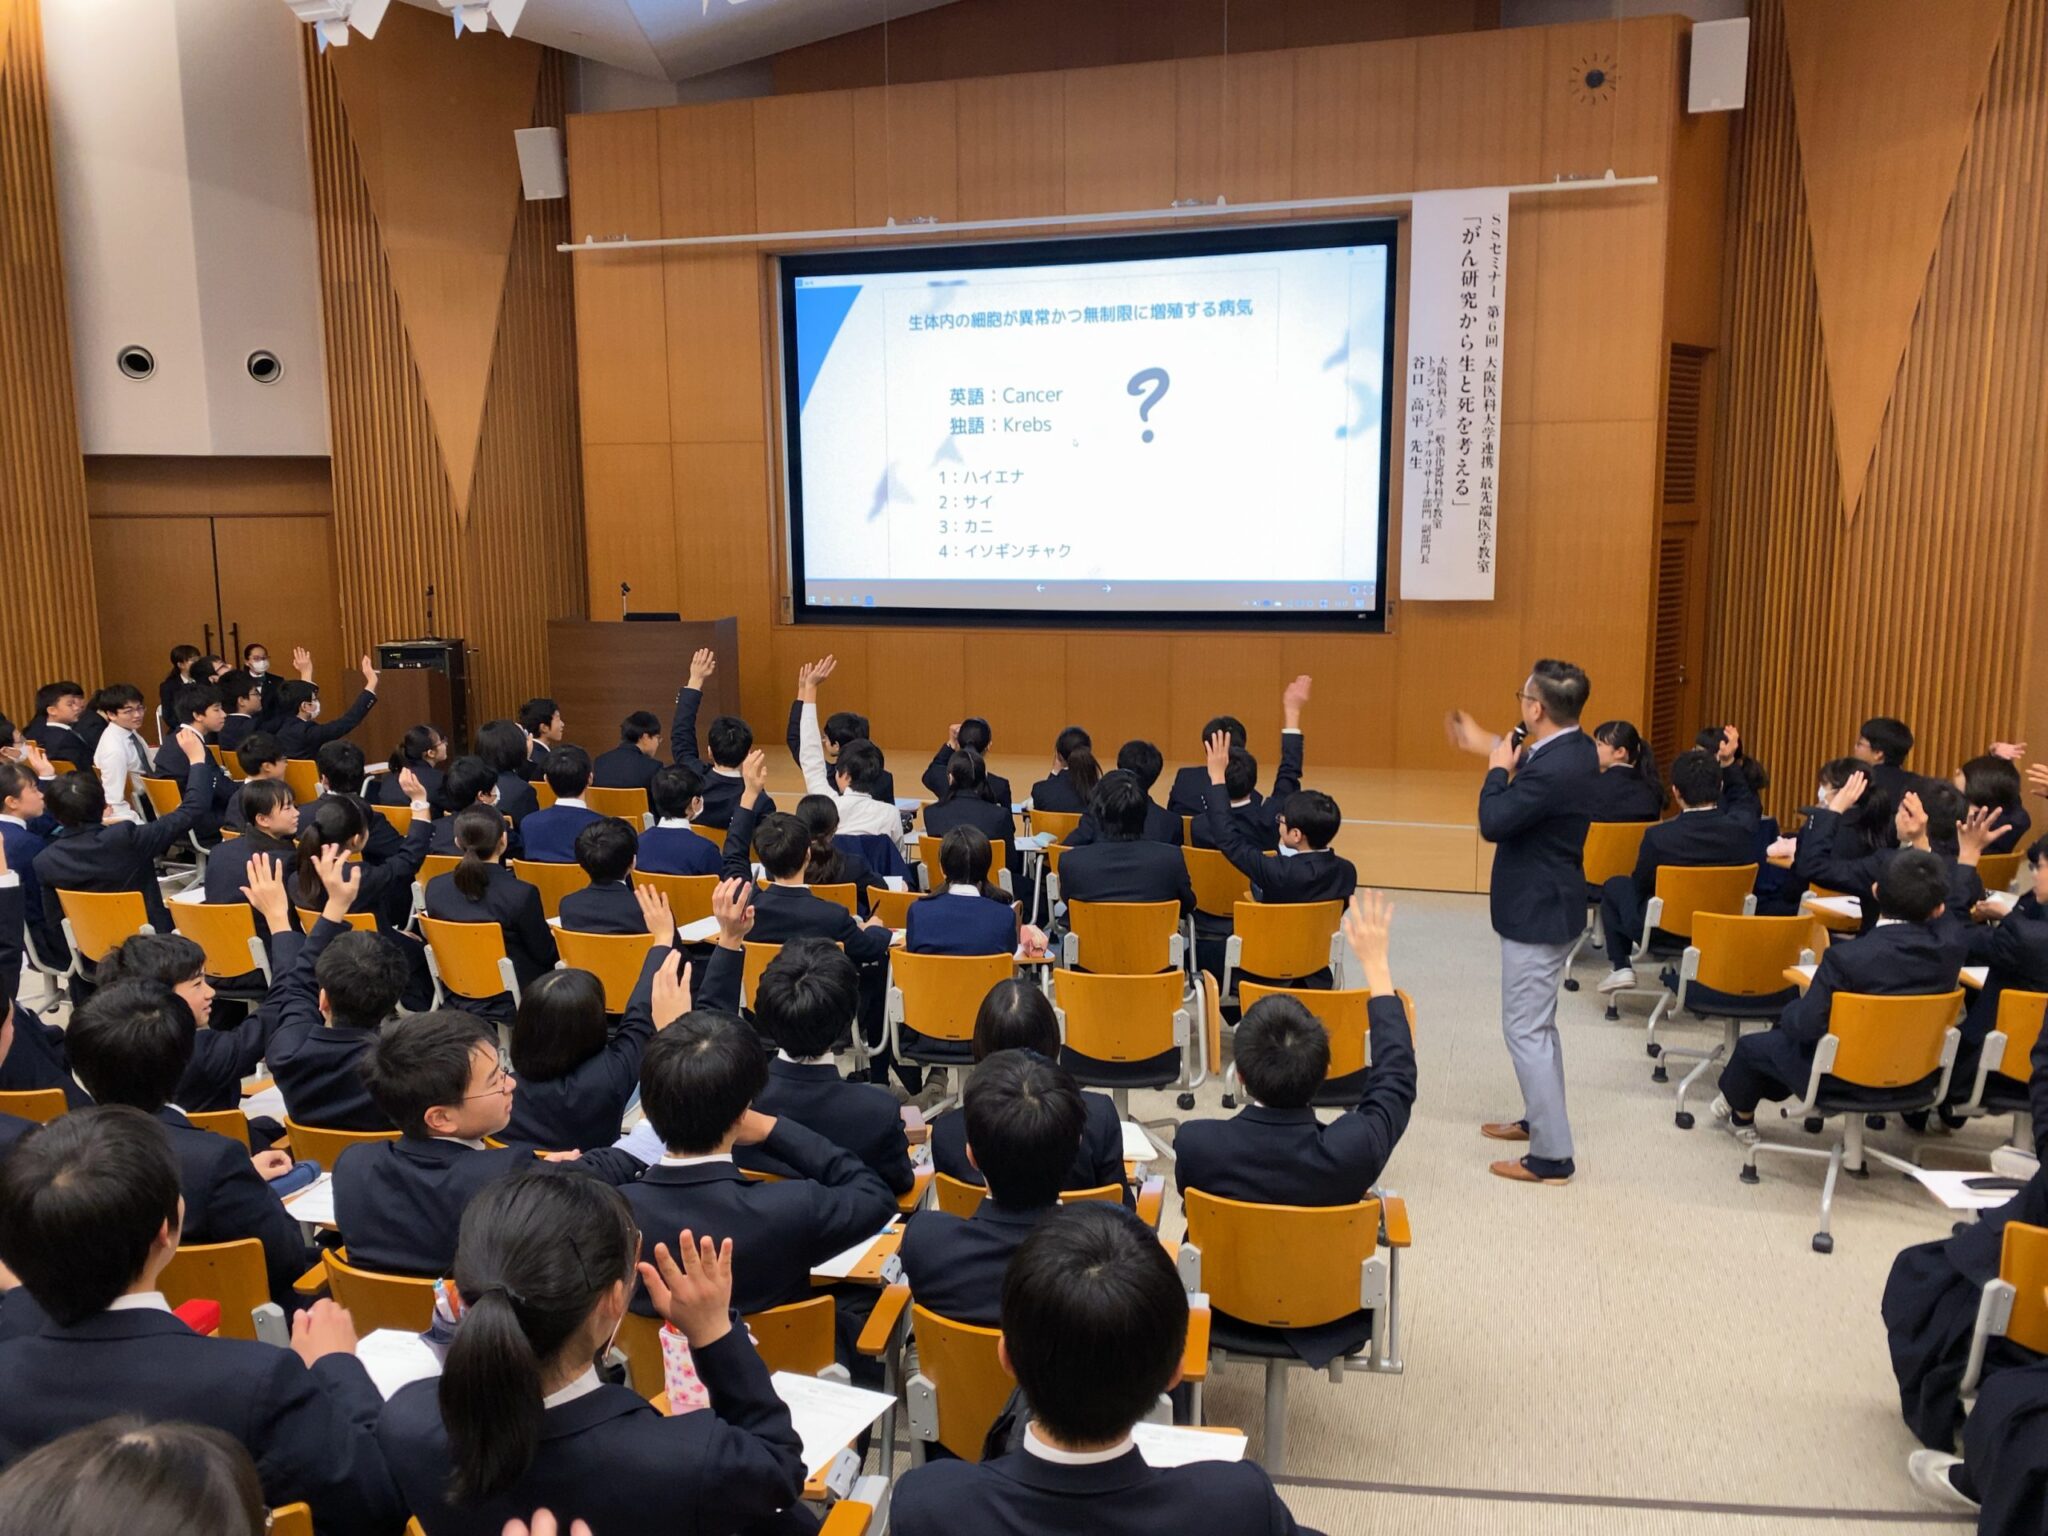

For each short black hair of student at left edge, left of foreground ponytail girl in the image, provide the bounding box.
[0,1104,178,1327]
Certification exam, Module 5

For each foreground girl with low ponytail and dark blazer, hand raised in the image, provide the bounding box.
[377,1171,815,1536]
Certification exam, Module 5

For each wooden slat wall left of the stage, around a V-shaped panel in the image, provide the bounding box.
[305,33,584,729]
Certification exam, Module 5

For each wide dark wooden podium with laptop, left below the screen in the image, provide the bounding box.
[547,618,739,760]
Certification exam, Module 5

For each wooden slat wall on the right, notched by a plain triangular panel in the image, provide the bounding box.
[1706,0,2048,813]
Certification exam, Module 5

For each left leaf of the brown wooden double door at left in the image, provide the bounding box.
[78,518,221,704]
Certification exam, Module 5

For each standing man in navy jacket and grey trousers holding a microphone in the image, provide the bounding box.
[1446,659,1599,1184]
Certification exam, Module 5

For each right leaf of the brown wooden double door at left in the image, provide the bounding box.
[213,516,344,684]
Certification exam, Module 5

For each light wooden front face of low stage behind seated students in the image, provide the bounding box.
[764,741,1493,891]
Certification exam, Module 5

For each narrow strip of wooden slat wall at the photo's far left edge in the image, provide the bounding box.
[0,0,102,725]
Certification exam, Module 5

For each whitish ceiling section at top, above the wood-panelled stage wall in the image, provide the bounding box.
[410,0,966,80]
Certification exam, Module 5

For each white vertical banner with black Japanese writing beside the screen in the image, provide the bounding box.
[1401,186,1507,602]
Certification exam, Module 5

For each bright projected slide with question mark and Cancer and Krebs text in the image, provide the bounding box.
[782,223,1393,623]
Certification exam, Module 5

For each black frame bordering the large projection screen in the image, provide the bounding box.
[774,217,1401,635]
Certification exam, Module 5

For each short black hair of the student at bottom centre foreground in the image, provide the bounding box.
[1001,1200,1188,1446]
